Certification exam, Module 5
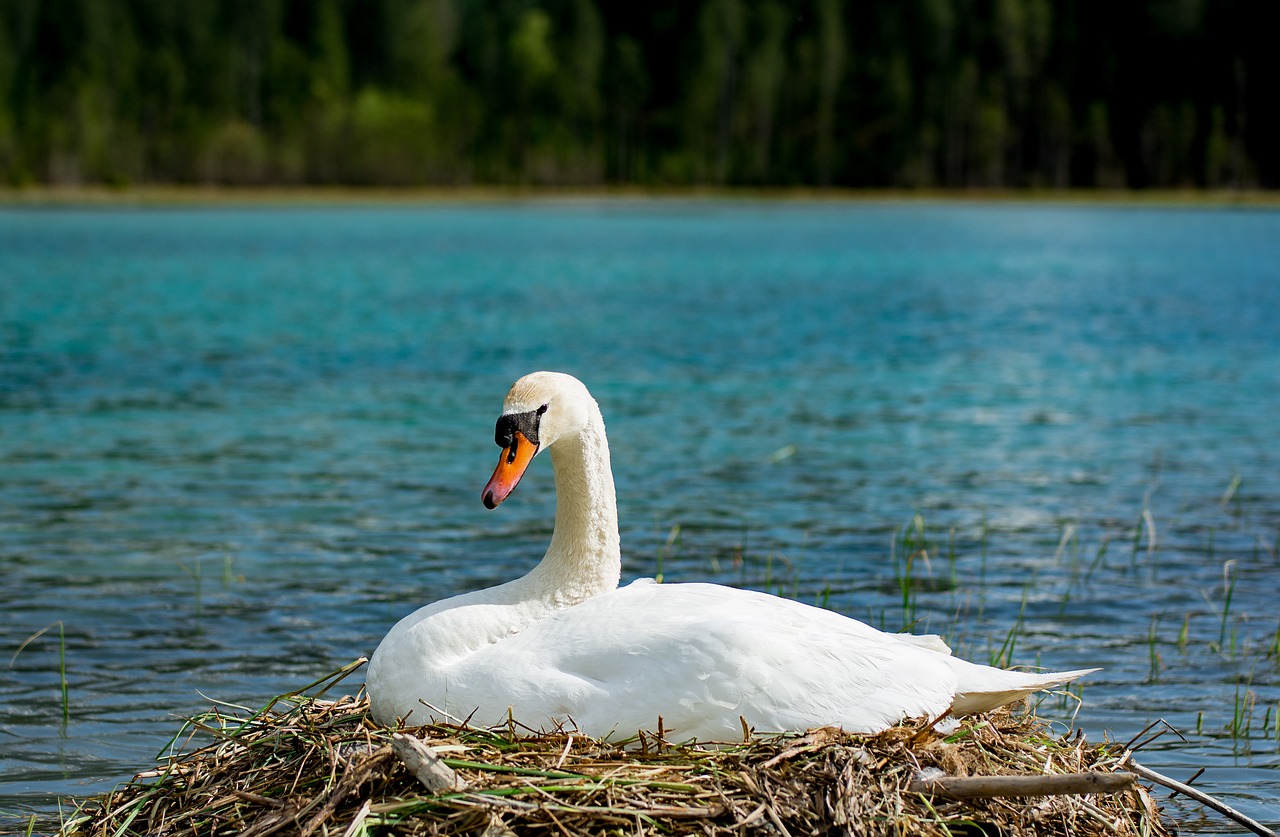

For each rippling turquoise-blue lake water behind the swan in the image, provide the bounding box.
[0,201,1280,832]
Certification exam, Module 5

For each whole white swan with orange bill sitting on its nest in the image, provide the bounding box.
[366,371,1097,742]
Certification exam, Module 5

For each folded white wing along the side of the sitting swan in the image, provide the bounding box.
[451,584,956,741]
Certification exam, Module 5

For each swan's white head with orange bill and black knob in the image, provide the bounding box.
[480,372,595,508]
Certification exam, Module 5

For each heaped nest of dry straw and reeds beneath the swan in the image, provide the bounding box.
[63,660,1169,837]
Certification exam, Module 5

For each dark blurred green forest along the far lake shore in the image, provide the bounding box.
[0,0,1280,189]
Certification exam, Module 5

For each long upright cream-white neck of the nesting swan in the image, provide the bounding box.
[526,404,622,607]
